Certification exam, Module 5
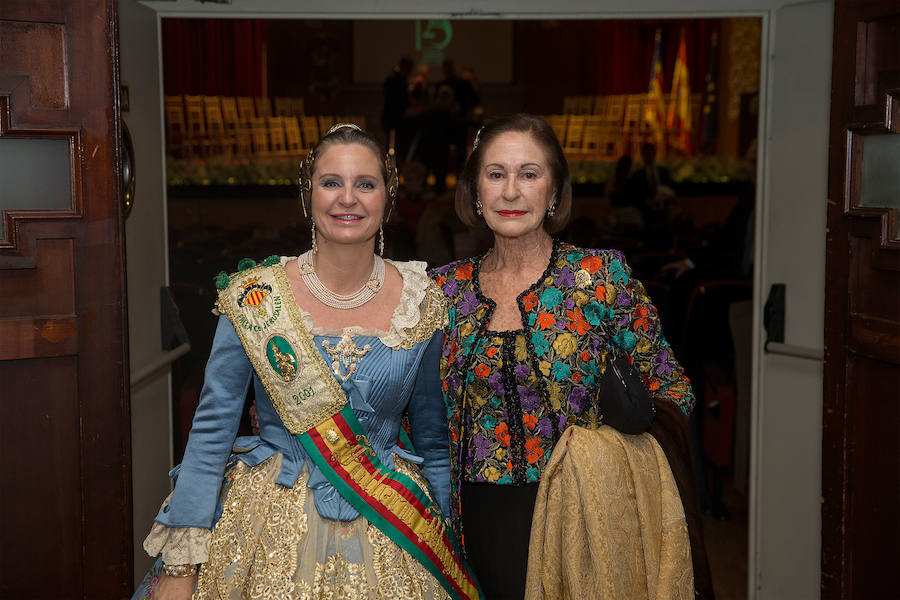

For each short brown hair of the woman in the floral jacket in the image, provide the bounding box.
[456,113,572,233]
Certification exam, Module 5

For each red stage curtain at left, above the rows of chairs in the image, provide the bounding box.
[162,19,265,97]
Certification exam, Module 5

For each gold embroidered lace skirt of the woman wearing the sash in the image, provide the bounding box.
[193,454,449,600]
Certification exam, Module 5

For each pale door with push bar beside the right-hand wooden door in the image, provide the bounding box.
[751,1,834,599]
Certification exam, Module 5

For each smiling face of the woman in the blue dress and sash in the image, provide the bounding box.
[311,144,387,244]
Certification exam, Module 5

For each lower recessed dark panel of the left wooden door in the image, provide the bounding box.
[0,355,87,598]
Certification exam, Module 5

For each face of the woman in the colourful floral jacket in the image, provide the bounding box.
[478,131,553,238]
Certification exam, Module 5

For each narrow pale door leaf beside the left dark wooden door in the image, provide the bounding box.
[119,0,172,581]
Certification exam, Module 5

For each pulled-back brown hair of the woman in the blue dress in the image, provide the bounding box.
[299,124,398,222]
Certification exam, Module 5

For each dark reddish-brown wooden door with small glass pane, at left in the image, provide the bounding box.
[0,0,132,599]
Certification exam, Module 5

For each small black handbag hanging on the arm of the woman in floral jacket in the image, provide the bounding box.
[597,355,656,434]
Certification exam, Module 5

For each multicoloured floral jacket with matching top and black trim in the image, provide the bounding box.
[431,240,694,492]
